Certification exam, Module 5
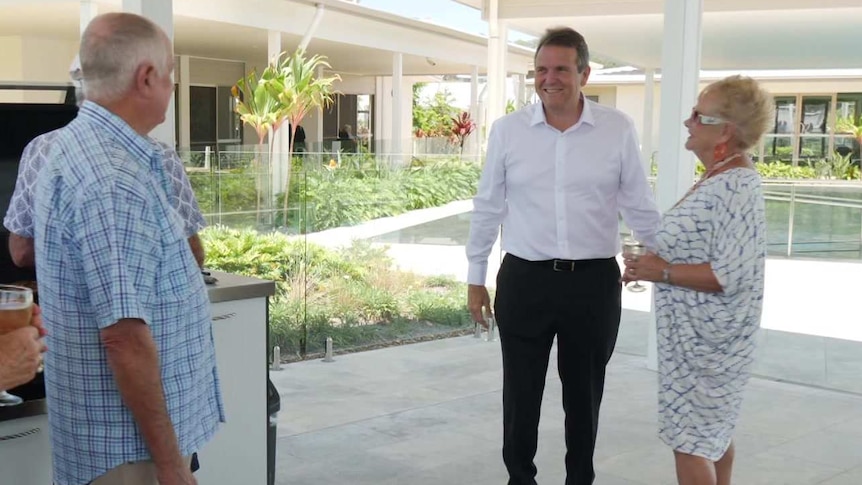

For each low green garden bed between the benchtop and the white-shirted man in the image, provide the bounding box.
[201,226,469,355]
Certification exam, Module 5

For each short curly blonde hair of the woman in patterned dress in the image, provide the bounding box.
[701,75,775,150]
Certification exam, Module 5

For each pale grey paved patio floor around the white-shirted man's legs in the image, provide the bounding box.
[272,332,862,485]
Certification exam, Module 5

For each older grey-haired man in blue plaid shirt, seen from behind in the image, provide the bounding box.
[34,13,224,485]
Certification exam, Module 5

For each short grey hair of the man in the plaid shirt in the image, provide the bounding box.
[80,13,173,102]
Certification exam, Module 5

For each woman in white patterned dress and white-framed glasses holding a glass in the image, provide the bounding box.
[623,76,774,485]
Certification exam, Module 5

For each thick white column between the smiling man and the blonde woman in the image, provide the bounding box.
[647,0,703,369]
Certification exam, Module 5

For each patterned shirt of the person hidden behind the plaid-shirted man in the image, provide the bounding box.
[3,126,206,239]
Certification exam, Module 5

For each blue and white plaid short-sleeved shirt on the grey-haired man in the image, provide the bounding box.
[34,102,224,485]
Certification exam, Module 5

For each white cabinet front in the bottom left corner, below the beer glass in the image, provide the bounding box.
[0,414,51,485]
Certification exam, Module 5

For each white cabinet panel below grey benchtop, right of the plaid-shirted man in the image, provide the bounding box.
[195,298,267,485]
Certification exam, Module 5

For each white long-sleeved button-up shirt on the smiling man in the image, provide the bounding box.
[467,98,660,285]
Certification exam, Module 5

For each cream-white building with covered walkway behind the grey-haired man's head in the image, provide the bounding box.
[0,0,532,153]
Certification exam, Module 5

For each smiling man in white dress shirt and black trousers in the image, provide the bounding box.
[467,28,659,485]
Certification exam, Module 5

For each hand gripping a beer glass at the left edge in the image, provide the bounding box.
[0,326,46,389]
